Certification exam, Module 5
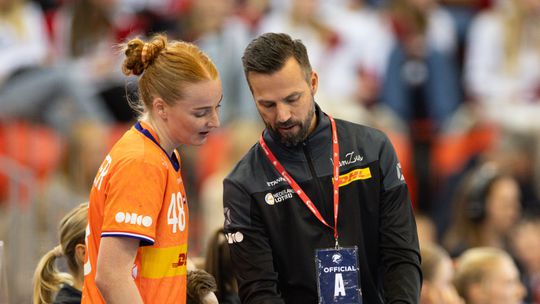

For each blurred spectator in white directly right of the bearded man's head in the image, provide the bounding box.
[321,0,393,109]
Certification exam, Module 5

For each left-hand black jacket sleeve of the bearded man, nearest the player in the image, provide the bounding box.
[223,179,284,304]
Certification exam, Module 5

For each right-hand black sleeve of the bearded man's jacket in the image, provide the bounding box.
[379,134,422,304]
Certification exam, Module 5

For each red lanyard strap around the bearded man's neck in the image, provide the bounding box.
[259,113,339,248]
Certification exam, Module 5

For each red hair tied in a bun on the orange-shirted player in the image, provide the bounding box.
[122,34,218,116]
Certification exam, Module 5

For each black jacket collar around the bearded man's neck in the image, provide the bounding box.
[263,104,332,161]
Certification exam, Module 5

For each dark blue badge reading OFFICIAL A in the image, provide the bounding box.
[315,246,362,304]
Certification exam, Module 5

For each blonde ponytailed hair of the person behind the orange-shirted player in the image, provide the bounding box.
[33,203,88,304]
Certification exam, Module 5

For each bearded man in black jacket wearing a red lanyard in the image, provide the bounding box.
[223,33,422,304]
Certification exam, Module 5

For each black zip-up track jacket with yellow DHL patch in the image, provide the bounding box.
[223,106,422,304]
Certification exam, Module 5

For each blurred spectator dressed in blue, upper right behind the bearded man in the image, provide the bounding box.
[380,0,462,212]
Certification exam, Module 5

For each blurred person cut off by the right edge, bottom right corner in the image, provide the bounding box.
[512,216,540,303]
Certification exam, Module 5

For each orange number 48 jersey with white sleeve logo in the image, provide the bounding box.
[82,123,189,303]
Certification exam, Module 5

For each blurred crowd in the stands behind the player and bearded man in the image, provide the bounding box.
[0,0,540,303]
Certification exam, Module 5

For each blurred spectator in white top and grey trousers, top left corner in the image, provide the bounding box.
[0,0,110,134]
